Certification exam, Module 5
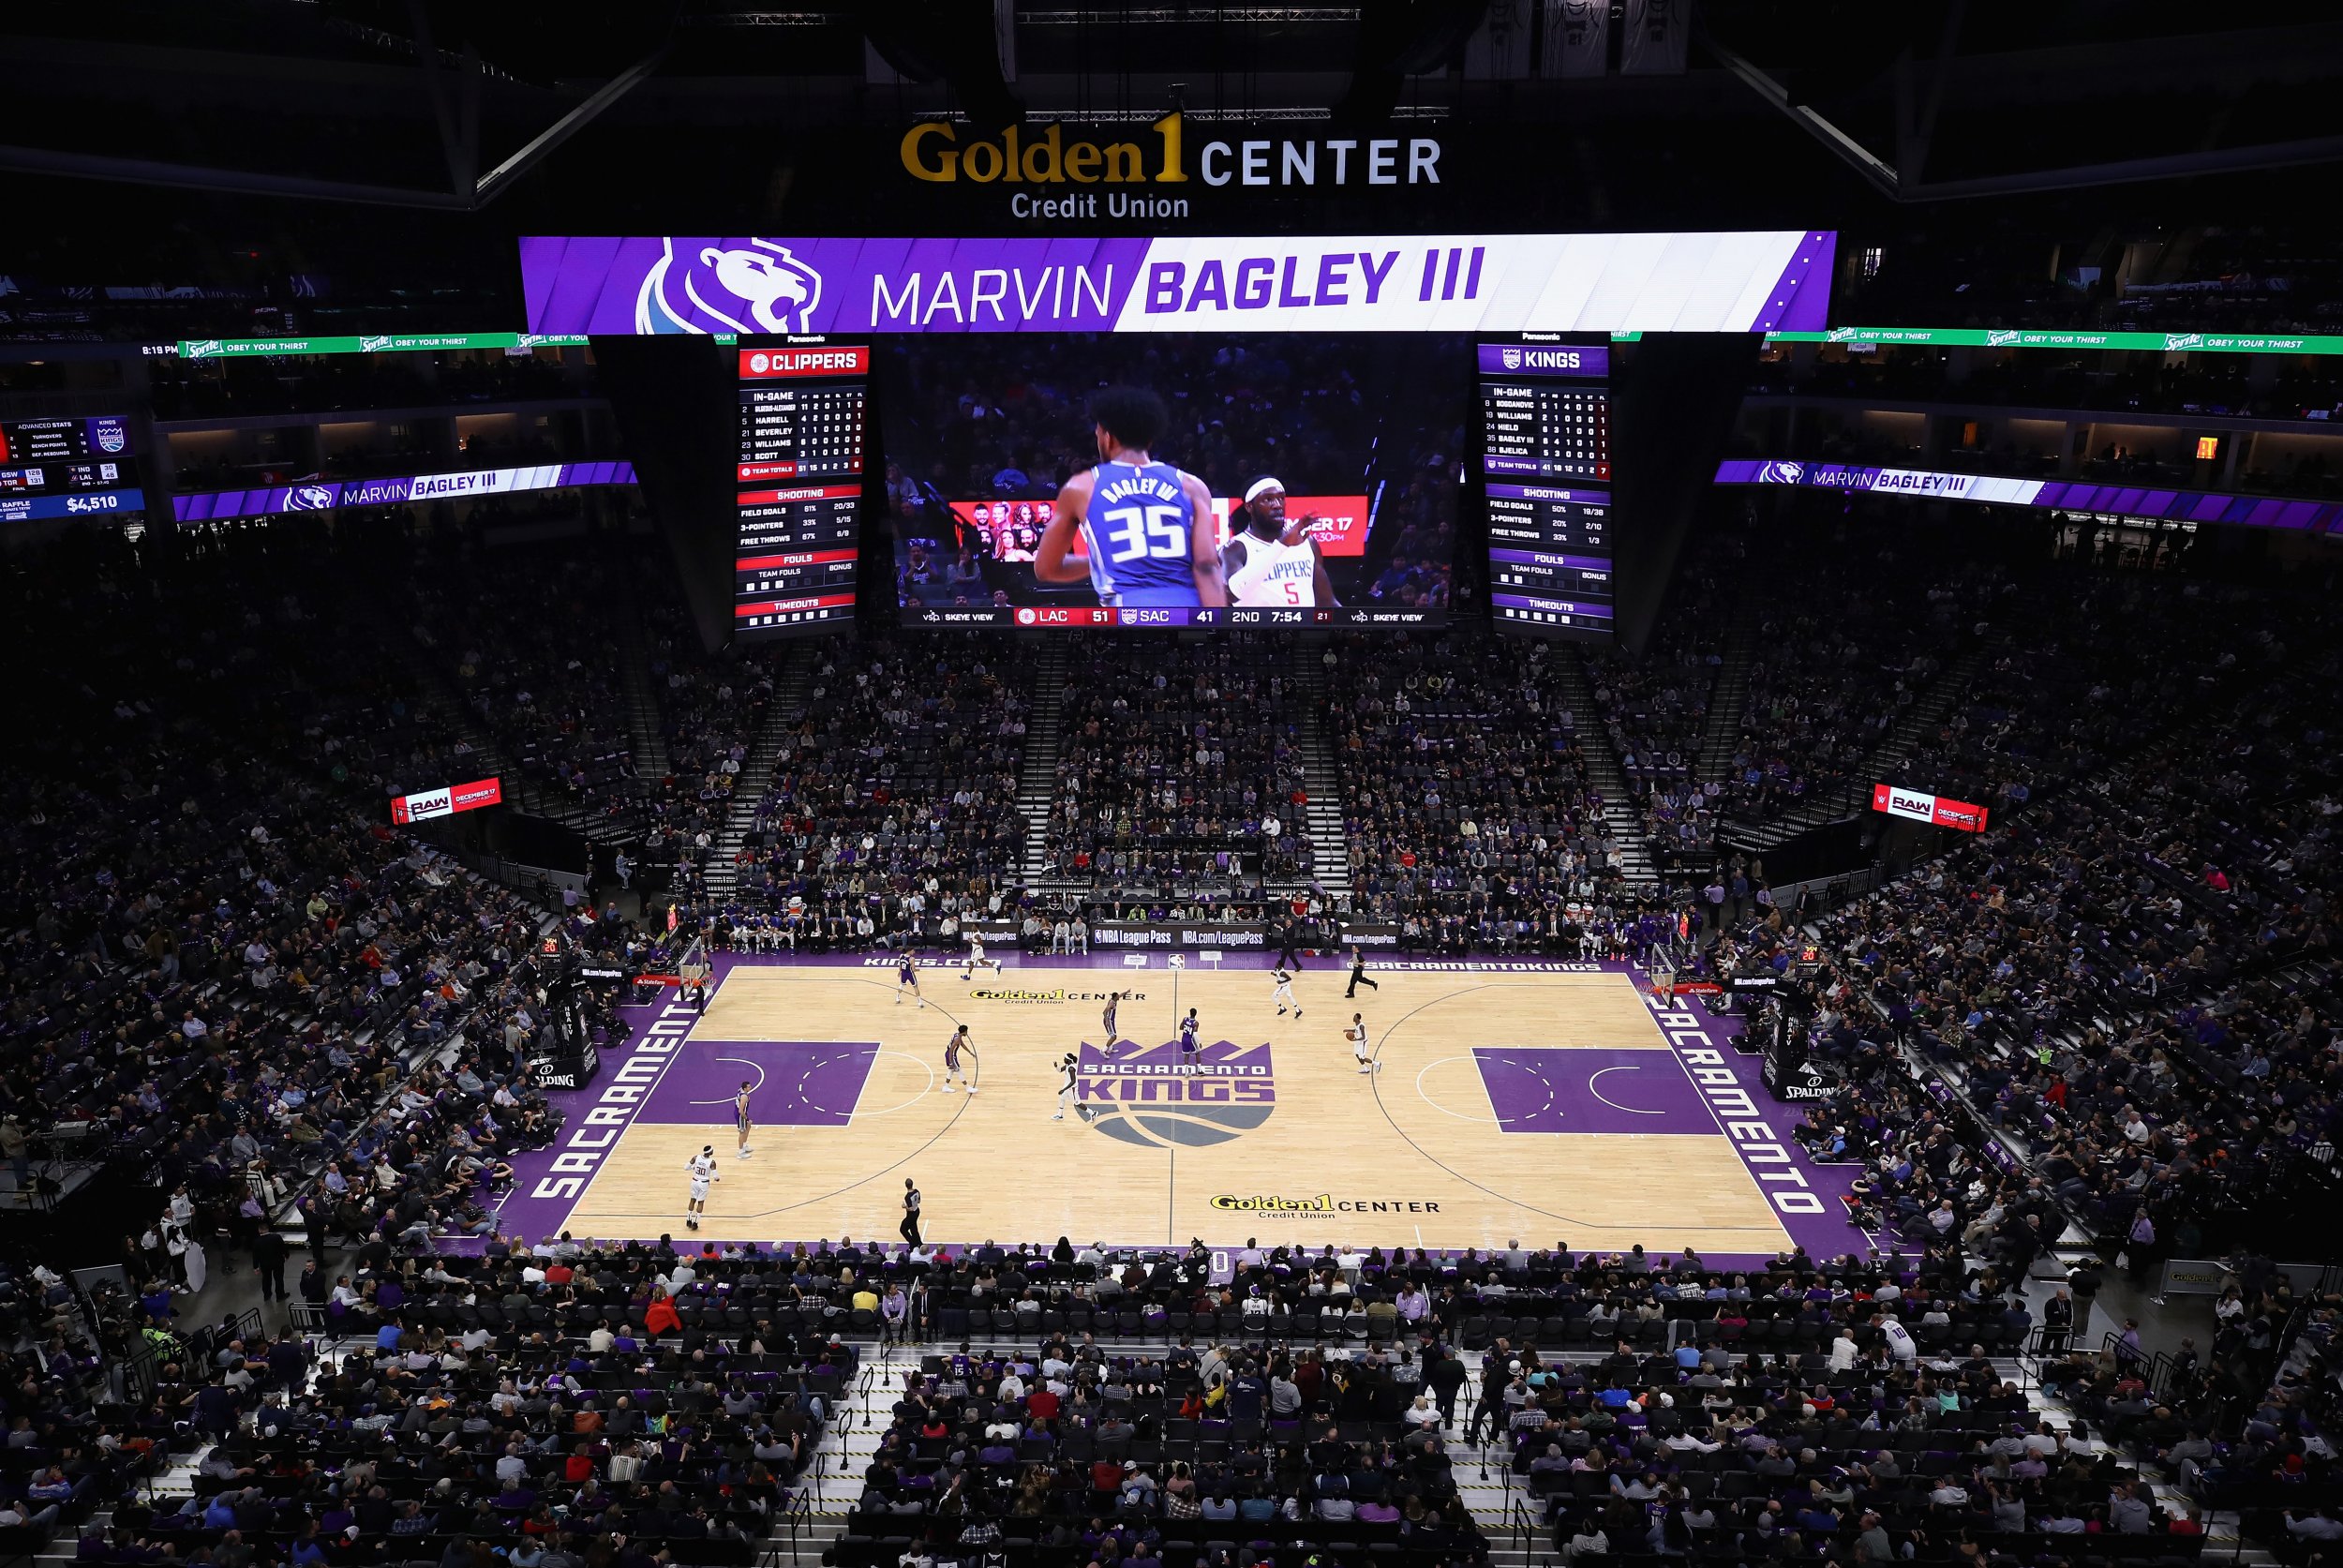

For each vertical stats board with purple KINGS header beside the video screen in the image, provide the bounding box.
[1481,336,1615,640]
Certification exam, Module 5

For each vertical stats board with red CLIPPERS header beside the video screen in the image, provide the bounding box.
[734,340,872,637]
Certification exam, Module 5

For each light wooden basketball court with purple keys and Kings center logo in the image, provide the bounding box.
[509,954,1860,1256]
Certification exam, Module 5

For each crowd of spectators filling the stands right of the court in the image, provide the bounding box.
[1734,569,2338,1268]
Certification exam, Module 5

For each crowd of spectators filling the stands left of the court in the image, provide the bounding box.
[0,530,651,1331]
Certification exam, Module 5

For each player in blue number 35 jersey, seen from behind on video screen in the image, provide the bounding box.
[1034,387,1228,609]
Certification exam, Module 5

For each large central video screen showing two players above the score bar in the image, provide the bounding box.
[874,333,1474,628]
